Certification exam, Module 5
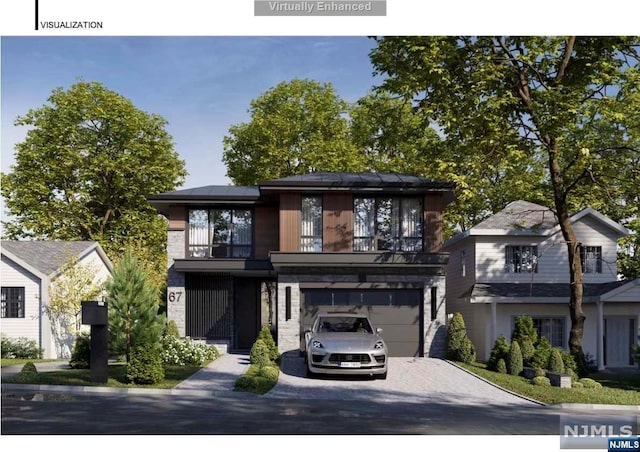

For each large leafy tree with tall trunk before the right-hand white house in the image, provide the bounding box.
[371,36,640,366]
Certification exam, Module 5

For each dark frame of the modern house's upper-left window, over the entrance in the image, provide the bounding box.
[186,206,255,259]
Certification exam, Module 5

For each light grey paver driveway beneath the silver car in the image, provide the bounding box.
[264,357,538,407]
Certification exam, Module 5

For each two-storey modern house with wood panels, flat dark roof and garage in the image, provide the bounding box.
[149,173,454,356]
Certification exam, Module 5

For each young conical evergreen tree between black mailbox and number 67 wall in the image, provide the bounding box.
[106,249,165,362]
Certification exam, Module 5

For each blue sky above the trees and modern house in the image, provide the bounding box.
[0,36,376,188]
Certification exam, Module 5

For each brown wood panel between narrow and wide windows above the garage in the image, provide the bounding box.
[322,193,353,252]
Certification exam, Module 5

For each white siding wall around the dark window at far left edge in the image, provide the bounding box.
[0,256,42,346]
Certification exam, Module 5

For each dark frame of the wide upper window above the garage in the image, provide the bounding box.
[353,194,425,252]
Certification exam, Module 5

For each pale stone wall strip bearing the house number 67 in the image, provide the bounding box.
[167,230,187,336]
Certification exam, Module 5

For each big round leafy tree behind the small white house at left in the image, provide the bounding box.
[2,81,186,283]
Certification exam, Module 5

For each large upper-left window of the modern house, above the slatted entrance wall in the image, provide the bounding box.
[189,209,253,258]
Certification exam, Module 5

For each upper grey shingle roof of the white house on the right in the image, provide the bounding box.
[443,200,631,248]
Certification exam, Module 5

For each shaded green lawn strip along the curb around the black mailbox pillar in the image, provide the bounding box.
[2,363,208,389]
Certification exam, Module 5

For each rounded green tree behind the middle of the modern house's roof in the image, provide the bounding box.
[223,79,365,185]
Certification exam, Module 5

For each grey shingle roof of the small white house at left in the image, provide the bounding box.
[1,240,111,277]
